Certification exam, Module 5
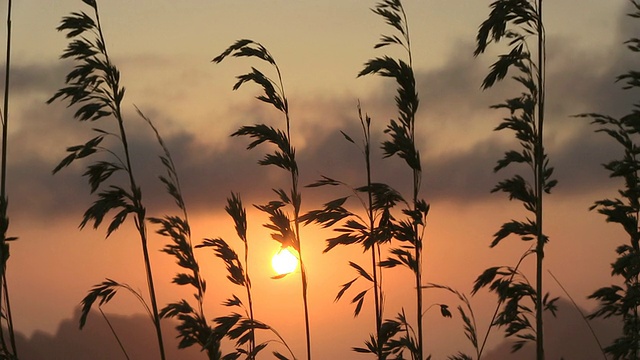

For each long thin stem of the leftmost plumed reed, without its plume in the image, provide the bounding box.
[94,2,166,360]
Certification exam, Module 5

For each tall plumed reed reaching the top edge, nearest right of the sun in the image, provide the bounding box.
[358,0,429,360]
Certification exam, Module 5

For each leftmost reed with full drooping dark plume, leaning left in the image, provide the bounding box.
[48,0,165,360]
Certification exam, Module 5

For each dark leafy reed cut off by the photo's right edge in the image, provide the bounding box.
[579,0,640,359]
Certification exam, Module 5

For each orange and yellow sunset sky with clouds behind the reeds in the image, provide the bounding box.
[0,0,639,359]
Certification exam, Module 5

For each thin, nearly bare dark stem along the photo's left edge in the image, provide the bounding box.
[0,0,18,359]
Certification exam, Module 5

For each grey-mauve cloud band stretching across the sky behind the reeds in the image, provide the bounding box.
[3,2,637,225]
